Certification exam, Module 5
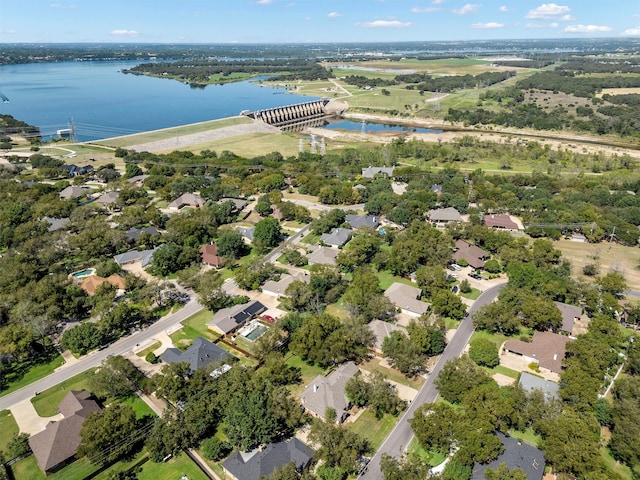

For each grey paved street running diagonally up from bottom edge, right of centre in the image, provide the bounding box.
[358,284,505,480]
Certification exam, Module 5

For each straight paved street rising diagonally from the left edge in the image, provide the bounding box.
[0,299,204,410]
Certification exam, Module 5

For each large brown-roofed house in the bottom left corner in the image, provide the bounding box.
[29,390,100,475]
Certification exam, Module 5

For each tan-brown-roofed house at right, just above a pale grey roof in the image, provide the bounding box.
[504,332,572,374]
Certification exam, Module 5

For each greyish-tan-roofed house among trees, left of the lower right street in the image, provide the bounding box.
[300,362,359,423]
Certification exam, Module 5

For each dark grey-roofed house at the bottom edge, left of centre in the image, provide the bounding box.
[221,437,313,480]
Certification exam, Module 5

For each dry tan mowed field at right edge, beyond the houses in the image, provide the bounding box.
[555,240,640,290]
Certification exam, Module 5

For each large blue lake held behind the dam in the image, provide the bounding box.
[0,61,316,141]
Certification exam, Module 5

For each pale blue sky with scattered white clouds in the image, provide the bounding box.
[0,0,640,43]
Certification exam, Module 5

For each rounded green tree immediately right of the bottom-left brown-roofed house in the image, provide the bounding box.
[78,405,143,465]
